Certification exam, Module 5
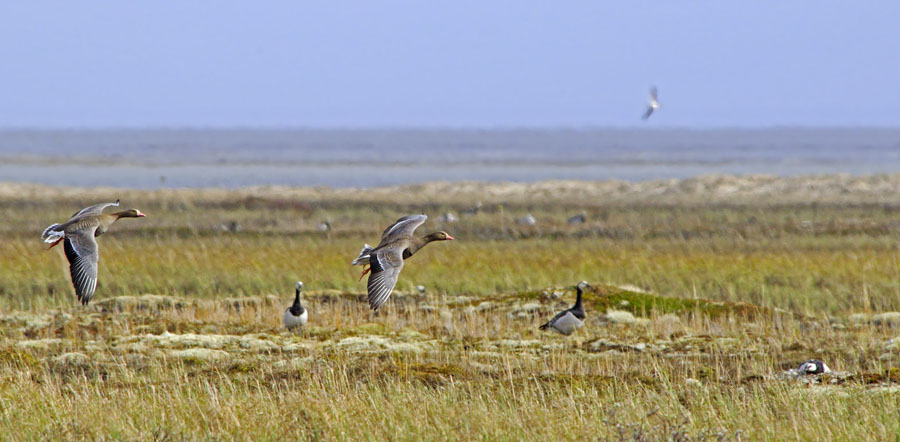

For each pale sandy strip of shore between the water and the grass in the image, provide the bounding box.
[0,174,900,206]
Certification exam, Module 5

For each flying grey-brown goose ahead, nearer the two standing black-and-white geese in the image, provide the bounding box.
[353,215,453,311]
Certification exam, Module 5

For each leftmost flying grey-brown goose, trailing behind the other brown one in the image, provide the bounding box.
[41,200,145,305]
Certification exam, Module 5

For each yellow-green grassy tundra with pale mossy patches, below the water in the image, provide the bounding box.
[0,179,900,440]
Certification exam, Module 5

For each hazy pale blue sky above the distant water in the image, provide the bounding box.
[0,0,900,128]
